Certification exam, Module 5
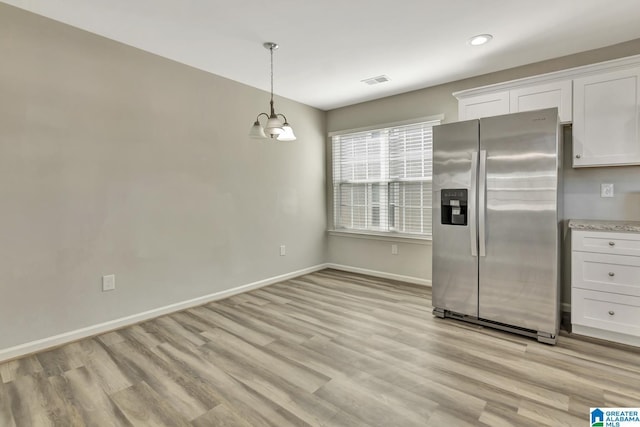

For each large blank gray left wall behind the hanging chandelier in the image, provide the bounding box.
[0,4,326,350]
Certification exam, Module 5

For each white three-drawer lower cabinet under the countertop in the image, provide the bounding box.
[571,230,640,346]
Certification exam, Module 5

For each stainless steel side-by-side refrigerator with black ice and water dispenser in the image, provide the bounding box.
[432,108,562,344]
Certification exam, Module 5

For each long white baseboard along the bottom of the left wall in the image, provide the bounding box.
[0,264,328,362]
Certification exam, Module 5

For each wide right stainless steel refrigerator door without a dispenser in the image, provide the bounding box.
[478,109,560,335]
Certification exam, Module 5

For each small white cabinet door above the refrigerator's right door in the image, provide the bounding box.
[509,80,571,123]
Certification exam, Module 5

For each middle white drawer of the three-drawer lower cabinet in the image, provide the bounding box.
[571,252,640,297]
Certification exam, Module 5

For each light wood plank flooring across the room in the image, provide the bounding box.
[0,270,640,427]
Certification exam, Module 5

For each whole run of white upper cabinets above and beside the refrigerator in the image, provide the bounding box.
[453,55,640,168]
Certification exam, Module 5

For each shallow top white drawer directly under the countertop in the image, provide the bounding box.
[571,230,640,256]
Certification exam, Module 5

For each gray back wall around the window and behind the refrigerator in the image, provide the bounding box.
[327,36,640,303]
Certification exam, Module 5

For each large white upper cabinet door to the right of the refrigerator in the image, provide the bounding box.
[573,68,640,167]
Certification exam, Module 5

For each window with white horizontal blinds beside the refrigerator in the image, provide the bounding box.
[332,120,440,237]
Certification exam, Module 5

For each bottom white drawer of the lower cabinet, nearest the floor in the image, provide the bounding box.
[571,288,640,336]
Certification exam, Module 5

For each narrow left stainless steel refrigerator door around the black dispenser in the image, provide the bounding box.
[432,120,479,316]
